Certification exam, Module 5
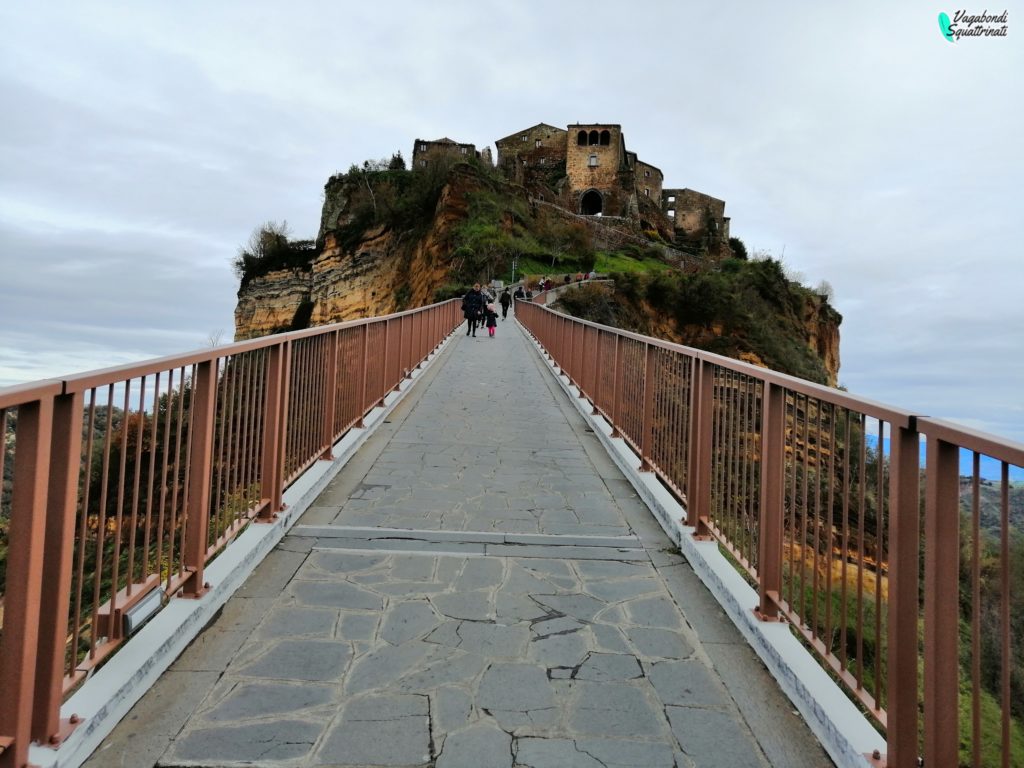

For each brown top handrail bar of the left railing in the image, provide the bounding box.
[0,299,456,397]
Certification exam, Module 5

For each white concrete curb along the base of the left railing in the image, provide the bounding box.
[29,333,454,768]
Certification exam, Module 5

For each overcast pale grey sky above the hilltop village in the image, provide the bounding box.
[0,0,1024,441]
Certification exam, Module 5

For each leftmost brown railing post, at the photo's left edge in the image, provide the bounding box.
[0,395,53,768]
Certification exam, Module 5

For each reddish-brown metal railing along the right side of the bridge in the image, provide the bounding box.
[516,302,1024,767]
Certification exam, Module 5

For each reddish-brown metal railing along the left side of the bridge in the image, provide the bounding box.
[0,300,462,768]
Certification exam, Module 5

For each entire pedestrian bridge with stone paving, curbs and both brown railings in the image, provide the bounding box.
[0,302,1024,768]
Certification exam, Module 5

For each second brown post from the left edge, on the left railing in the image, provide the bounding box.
[32,392,83,744]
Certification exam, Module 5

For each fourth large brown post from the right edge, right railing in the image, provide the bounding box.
[686,356,715,538]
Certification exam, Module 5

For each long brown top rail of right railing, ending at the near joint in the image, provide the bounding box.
[535,304,914,429]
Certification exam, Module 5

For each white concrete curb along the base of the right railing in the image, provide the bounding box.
[520,324,886,768]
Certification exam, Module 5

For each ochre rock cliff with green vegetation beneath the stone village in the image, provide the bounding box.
[234,164,842,385]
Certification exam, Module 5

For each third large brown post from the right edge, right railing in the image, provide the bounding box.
[756,382,785,622]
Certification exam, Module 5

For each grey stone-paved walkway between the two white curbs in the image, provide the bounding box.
[87,319,830,768]
